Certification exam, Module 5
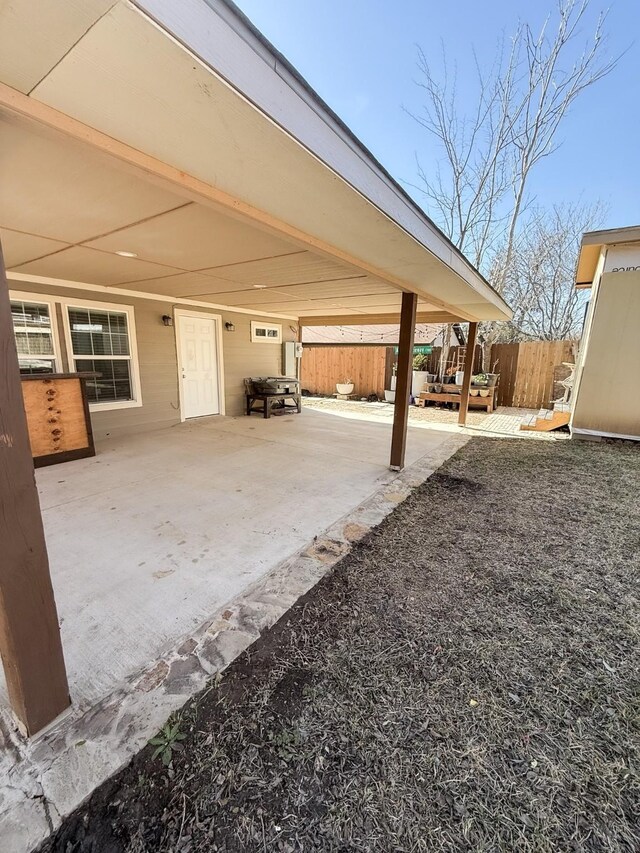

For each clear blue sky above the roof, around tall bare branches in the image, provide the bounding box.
[236,0,640,228]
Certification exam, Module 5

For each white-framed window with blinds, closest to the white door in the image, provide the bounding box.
[67,305,136,408]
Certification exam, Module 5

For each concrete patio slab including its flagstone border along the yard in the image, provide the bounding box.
[0,410,468,853]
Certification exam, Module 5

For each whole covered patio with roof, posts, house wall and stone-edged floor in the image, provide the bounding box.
[0,0,510,837]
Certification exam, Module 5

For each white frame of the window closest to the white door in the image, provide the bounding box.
[59,297,142,412]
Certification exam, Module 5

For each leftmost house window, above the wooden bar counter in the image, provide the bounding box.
[11,299,56,374]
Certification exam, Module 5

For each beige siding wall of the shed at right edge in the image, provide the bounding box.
[572,272,640,437]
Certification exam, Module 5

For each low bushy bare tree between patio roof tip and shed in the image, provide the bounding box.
[493,203,603,341]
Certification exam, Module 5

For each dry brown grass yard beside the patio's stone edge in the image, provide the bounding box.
[46,438,640,853]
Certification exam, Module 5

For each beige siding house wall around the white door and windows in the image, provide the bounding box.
[10,282,296,438]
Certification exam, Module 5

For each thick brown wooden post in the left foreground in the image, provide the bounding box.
[0,240,69,735]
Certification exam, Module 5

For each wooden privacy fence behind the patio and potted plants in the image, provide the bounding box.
[302,341,576,409]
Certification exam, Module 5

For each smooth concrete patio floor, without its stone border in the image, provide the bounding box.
[2,411,466,707]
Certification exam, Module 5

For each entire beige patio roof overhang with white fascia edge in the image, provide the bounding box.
[0,0,510,325]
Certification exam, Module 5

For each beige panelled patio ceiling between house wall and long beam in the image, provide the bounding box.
[0,116,424,317]
